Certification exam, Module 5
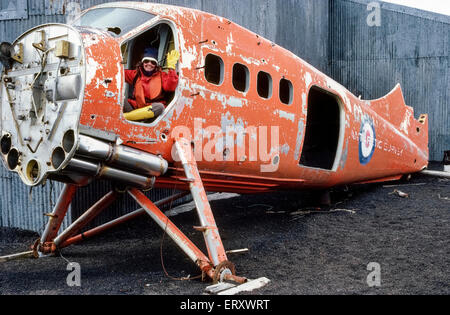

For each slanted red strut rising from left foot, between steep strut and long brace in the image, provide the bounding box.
[53,190,119,247]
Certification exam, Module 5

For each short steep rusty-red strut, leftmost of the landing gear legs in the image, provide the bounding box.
[41,184,77,244]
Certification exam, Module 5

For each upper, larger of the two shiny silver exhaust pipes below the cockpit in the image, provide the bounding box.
[76,135,168,176]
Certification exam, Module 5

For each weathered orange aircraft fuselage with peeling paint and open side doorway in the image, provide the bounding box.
[0,2,428,193]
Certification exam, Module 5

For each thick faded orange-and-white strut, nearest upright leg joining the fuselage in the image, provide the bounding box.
[175,138,227,266]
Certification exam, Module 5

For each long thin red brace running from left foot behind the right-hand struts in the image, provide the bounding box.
[59,192,189,248]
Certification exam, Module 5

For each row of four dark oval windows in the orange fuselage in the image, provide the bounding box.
[205,54,294,105]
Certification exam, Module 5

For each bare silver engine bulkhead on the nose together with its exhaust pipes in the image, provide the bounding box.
[0,24,168,189]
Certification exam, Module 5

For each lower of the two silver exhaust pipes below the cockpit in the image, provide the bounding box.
[64,159,155,189]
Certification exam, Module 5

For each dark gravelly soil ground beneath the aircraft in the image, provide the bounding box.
[0,163,450,295]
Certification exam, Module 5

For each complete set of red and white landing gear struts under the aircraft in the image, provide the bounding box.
[26,138,246,283]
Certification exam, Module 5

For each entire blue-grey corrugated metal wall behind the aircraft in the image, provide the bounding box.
[0,0,450,230]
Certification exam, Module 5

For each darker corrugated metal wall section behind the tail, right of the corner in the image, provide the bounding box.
[330,0,450,161]
